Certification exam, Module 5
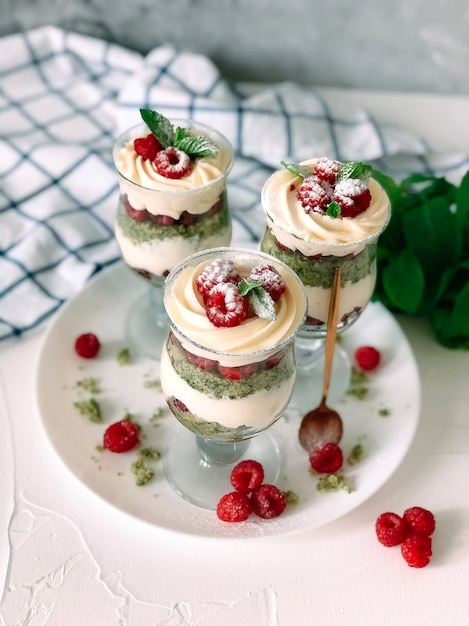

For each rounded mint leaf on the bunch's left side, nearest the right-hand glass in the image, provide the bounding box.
[381,249,425,313]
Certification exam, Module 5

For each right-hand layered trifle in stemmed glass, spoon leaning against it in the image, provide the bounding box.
[261,157,390,408]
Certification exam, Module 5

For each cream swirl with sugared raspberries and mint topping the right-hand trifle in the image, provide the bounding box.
[262,158,390,256]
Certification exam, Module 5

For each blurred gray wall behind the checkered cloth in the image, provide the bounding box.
[0,0,469,94]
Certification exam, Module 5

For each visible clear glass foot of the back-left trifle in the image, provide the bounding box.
[125,287,169,361]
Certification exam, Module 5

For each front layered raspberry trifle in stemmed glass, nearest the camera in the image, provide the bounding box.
[160,247,307,508]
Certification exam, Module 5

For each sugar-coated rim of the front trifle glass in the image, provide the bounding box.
[164,246,308,360]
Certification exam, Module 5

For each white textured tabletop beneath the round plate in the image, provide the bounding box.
[0,94,469,626]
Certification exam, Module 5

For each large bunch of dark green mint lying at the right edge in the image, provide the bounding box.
[372,170,469,350]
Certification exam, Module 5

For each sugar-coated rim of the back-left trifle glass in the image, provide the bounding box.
[112,118,234,195]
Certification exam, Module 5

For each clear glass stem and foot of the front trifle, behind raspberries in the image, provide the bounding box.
[163,428,281,510]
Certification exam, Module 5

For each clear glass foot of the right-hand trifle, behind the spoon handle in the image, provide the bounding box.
[289,339,352,415]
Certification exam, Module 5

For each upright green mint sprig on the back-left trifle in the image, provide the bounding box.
[140,109,218,159]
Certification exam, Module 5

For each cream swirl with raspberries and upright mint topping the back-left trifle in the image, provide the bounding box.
[113,109,233,219]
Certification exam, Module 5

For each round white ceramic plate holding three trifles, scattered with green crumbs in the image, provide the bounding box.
[37,264,420,538]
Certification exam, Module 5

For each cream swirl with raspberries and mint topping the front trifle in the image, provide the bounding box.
[165,248,307,365]
